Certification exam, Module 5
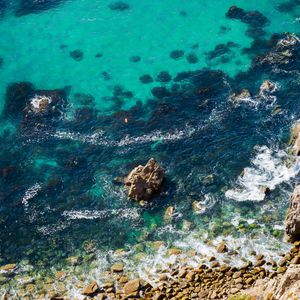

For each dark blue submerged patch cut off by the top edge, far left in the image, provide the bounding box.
[15,0,64,17]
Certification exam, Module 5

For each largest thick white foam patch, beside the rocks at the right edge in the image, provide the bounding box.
[225,146,300,201]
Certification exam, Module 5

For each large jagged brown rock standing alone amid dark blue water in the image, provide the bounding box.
[125,158,165,201]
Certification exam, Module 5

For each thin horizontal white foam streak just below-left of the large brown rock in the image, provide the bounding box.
[62,208,141,220]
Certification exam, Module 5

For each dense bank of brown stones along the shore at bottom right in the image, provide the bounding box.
[62,241,300,300]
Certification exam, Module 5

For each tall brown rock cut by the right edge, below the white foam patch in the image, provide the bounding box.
[285,185,300,242]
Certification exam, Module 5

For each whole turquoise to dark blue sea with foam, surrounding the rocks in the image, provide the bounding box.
[0,0,300,294]
